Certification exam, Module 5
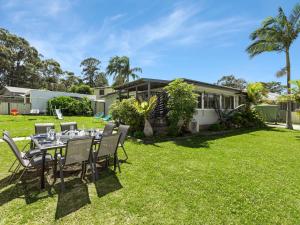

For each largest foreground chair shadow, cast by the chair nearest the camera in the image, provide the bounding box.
[55,178,91,220]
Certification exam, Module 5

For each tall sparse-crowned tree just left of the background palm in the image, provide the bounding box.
[80,57,101,87]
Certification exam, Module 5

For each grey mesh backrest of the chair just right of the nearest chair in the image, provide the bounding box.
[97,134,120,157]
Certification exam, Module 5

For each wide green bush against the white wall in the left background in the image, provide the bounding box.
[47,96,93,116]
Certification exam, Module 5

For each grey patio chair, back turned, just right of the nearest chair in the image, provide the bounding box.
[93,134,121,179]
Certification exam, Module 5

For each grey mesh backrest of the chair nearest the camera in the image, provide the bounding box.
[64,137,93,165]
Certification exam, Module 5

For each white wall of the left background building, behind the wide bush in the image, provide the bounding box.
[29,90,96,113]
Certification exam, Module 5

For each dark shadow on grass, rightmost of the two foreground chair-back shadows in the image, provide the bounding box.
[95,169,123,198]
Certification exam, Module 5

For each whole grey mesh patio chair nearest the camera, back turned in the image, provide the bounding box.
[54,137,94,191]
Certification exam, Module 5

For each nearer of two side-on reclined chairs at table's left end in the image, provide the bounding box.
[3,132,53,183]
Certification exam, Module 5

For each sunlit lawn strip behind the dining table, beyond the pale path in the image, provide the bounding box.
[0,115,104,137]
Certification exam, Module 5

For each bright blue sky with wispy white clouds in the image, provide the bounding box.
[0,0,300,83]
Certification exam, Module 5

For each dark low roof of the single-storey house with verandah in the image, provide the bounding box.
[114,78,242,93]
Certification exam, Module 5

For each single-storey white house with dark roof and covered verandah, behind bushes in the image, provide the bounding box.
[101,78,245,131]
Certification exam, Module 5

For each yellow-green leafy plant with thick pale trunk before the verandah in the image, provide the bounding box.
[134,96,157,137]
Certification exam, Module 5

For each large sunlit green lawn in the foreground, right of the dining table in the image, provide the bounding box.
[0,129,300,224]
